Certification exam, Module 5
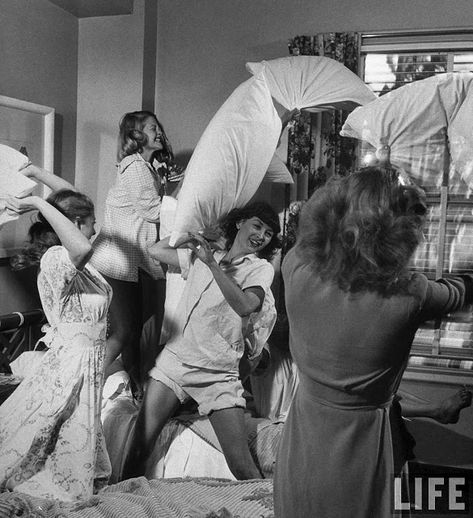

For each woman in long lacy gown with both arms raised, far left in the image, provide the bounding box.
[0,172,112,501]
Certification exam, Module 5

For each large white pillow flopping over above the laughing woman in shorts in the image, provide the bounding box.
[171,56,375,244]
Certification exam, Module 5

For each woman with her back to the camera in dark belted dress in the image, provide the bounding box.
[274,167,472,518]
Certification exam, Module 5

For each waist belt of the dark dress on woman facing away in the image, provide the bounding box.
[298,373,394,410]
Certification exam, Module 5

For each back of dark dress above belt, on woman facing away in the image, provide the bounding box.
[283,251,421,404]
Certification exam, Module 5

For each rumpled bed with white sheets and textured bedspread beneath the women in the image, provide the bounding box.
[0,346,297,518]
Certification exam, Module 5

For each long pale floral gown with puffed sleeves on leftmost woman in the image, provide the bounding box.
[0,246,112,501]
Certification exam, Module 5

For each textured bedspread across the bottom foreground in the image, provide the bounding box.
[0,477,274,518]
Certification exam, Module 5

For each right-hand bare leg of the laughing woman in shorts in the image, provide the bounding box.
[209,407,262,480]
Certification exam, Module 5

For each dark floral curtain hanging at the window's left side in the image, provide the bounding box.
[270,32,360,342]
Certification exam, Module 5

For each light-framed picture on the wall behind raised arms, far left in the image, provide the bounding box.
[0,95,55,261]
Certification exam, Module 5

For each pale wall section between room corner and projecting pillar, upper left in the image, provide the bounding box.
[76,0,144,224]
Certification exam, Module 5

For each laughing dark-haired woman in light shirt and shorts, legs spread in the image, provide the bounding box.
[123,202,280,480]
